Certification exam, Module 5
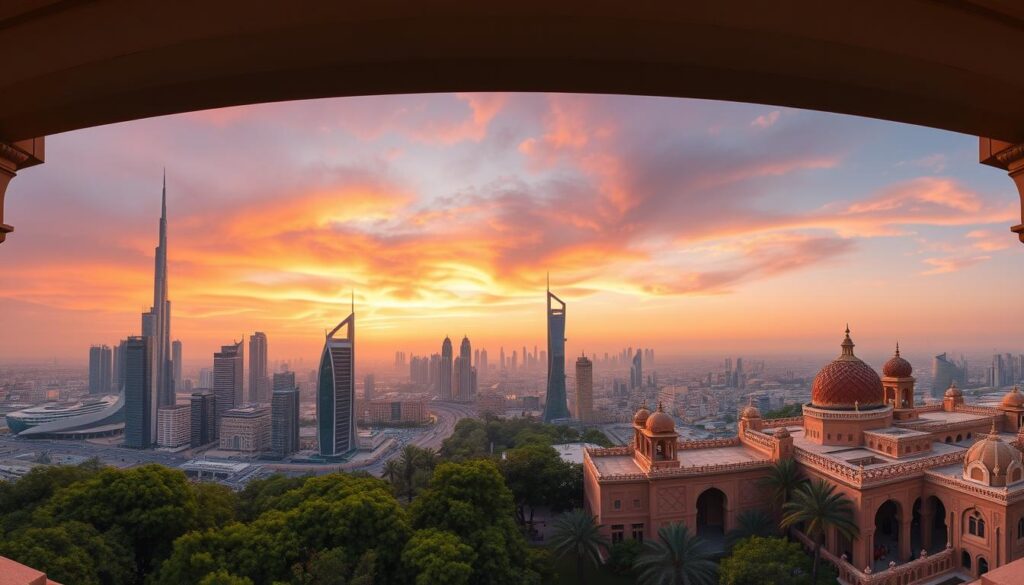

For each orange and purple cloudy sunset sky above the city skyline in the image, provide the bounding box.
[0,94,1024,366]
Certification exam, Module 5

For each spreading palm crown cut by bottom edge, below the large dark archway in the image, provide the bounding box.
[633,523,718,585]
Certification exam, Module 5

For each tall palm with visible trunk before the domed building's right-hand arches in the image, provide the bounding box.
[782,479,860,583]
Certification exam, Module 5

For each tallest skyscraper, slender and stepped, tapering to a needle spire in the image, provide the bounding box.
[142,173,175,409]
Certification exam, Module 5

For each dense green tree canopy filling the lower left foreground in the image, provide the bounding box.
[0,454,550,585]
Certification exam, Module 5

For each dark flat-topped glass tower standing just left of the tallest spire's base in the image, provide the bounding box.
[125,337,157,449]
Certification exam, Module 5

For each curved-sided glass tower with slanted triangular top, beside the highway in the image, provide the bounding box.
[316,302,356,457]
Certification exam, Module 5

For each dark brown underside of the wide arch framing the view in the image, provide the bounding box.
[0,0,1024,142]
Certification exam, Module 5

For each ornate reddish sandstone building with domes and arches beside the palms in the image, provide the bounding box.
[584,328,1024,585]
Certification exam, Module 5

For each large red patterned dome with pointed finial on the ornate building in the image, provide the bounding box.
[811,329,885,410]
